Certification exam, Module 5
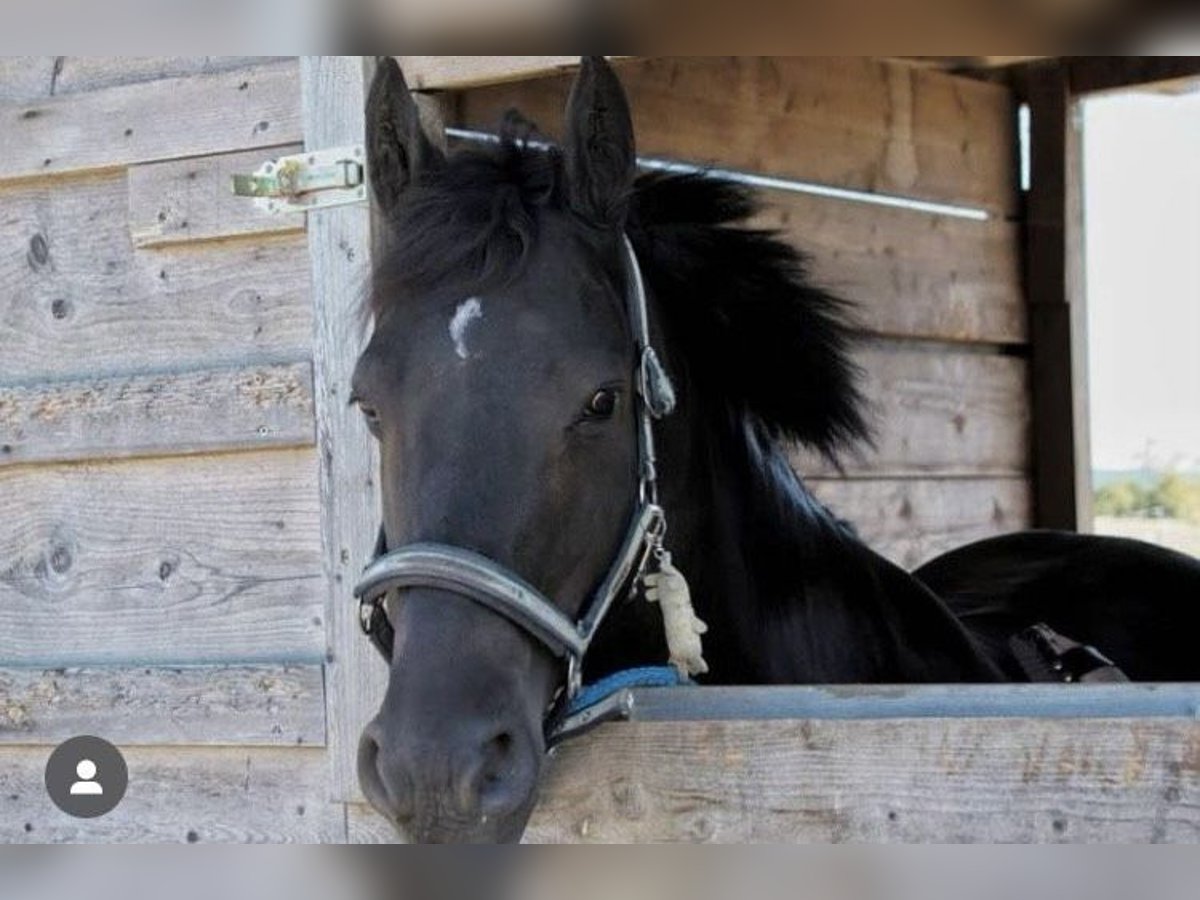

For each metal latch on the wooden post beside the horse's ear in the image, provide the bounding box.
[233,146,367,212]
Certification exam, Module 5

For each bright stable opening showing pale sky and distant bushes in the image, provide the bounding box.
[1080,82,1200,556]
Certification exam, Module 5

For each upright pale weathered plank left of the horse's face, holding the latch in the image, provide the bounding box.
[300,56,388,800]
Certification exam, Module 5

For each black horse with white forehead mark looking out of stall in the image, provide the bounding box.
[354,58,1200,841]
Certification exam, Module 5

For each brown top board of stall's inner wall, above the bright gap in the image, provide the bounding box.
[457,56,1016,212]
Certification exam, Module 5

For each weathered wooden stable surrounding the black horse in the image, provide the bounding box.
[0,56,1200,841]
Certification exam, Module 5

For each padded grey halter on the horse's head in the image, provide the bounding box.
[354,235,676,707]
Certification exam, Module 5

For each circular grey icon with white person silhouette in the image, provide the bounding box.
[46,734,130,818]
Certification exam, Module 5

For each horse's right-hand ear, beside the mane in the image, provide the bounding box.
[563,56,637,227]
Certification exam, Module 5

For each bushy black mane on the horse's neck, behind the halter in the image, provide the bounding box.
[630,174,869,460]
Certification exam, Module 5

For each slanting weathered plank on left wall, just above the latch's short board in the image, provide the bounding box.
[0,60,301,179]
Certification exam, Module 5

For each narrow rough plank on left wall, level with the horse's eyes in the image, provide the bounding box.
[0,361,313,466]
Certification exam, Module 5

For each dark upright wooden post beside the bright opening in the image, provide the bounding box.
[1021,61,1091,530]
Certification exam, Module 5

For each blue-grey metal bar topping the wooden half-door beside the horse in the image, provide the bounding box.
[630,683,1200,721]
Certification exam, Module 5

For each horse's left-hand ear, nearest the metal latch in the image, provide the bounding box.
[366,56,445,214]
